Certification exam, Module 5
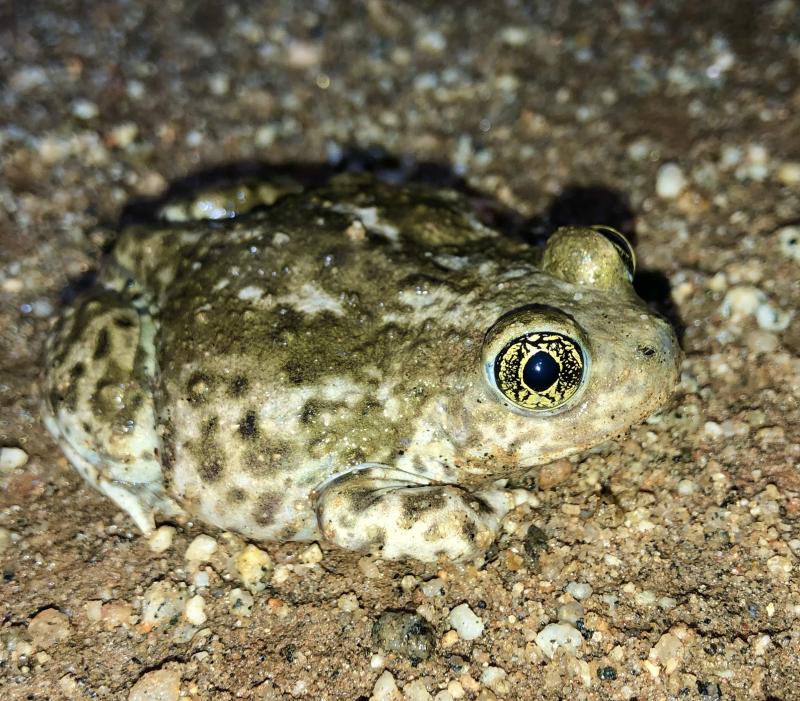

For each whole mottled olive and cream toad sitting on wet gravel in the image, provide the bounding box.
[43,174,681,561]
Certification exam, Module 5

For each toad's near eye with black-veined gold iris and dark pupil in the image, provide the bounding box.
[493,332,586,410]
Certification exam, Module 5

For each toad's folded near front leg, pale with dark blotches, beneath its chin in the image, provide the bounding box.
[317,466,515,561]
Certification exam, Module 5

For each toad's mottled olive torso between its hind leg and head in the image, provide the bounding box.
[152,180,506,540]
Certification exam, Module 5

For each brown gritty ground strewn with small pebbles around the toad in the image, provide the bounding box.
[0,0,800,701]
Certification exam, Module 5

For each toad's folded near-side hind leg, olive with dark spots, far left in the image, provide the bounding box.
[44,290,181,532]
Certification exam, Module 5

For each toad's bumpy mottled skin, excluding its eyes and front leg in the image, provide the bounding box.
[47,177,680,552]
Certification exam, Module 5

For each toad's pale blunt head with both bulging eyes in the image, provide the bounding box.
[454,227,680,474]
